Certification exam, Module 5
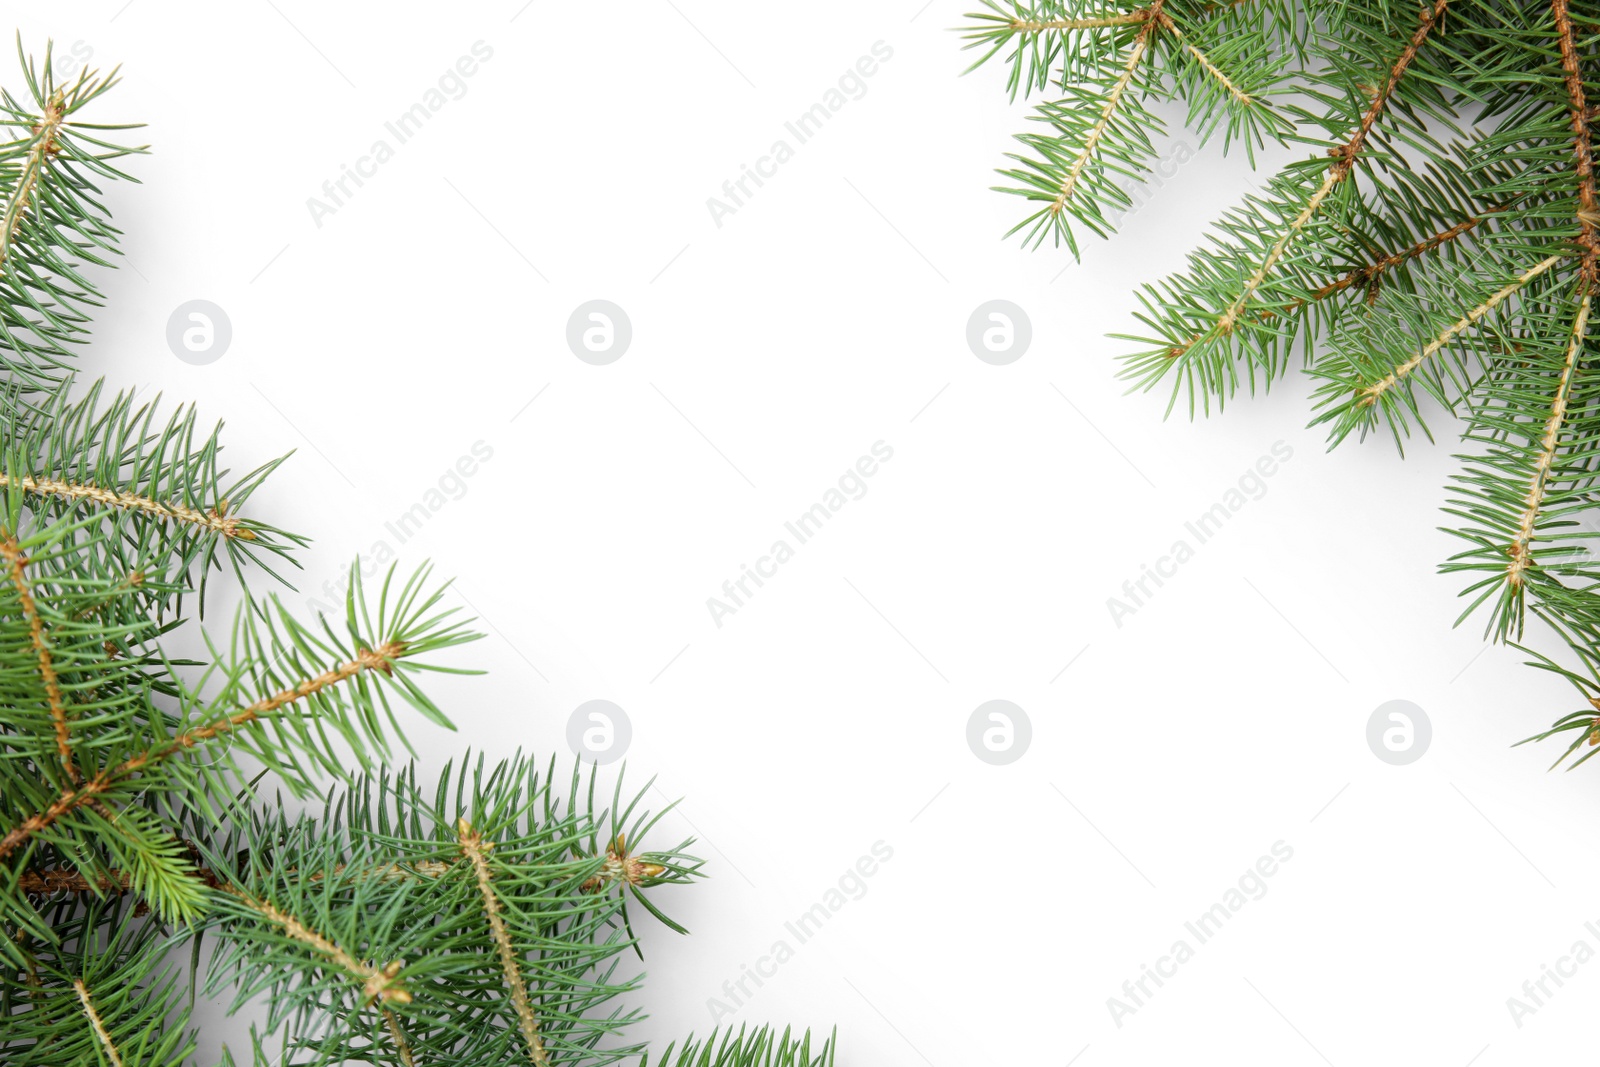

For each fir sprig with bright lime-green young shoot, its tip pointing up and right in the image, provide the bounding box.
[0,559,475,939]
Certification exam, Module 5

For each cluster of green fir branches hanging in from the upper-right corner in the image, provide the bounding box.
[965,0,1600,766]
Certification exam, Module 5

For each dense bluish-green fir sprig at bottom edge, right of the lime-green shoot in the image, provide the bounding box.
[196,757,699,1064]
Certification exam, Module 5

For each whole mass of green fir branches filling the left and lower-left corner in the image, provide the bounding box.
[0,43,832,1067]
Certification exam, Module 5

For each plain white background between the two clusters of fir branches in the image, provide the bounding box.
[5,0,1600,1067]
